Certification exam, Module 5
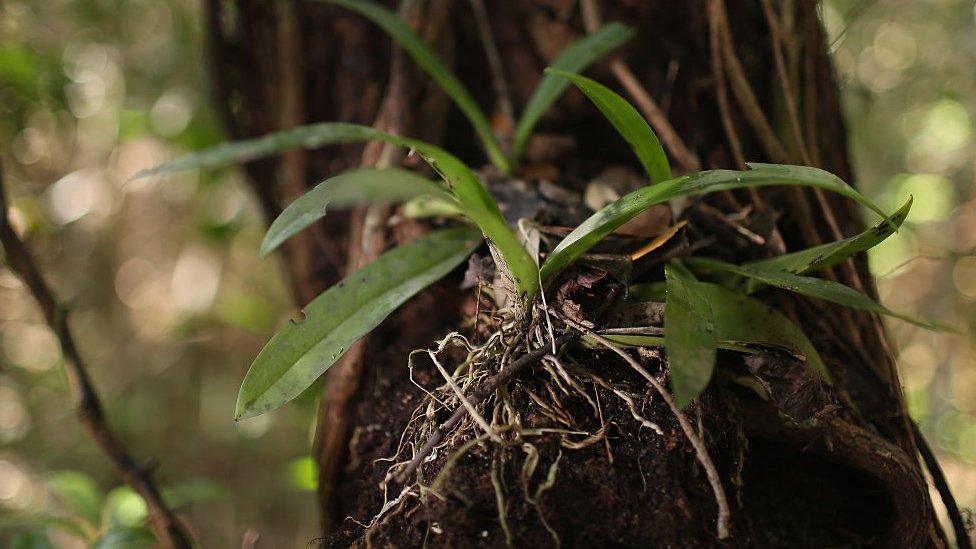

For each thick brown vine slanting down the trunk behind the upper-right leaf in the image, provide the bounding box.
[580,0,701,173]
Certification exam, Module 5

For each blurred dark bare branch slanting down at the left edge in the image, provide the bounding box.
[0,165,191,548]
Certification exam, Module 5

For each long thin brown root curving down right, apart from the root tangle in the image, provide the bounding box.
[561,317,731,539]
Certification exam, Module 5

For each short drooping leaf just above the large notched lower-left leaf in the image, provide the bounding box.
[260,168,454,257]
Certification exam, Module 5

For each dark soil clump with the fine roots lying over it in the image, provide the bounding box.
[324,278,904,547]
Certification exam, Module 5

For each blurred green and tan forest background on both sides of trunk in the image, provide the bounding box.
[0,0,976,547]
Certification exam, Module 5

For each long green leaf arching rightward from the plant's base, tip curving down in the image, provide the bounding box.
[542,164,886,280]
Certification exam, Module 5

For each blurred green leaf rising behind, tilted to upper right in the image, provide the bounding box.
[510,23,634,166]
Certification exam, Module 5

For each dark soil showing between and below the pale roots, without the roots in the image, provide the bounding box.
[325,296,908,547]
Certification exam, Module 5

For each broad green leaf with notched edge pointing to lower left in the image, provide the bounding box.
[235,227,481,419]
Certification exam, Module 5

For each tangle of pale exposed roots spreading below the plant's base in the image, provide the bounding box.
[363,292,729,546]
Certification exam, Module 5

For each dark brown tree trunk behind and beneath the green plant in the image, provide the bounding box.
[207,0,944,547]
